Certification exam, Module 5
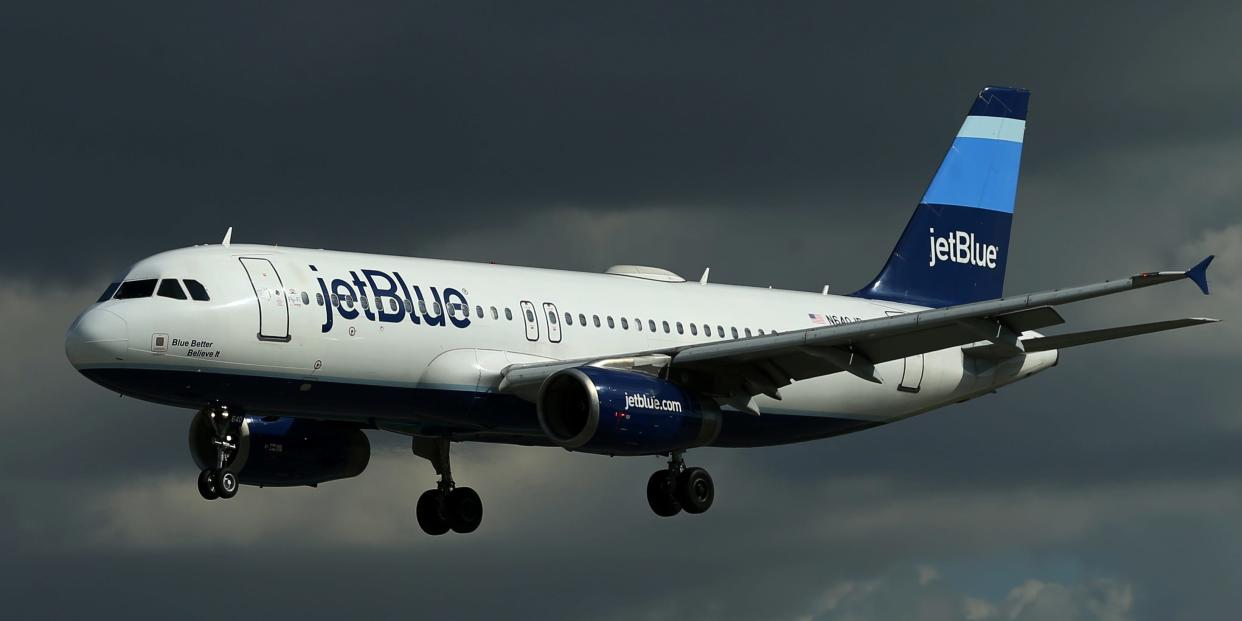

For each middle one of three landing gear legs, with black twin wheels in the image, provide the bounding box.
[412,437,483,535]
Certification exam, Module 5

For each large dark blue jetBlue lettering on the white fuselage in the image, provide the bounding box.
[308,266,469,333]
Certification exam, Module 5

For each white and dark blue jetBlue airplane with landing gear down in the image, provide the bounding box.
[65,87,1215,535]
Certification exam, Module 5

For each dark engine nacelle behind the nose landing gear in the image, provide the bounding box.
[190,414,371,487]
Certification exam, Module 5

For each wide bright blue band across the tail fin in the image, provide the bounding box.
[923,138,1022,214]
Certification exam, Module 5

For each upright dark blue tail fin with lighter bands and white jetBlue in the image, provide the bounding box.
[853,86,1031,307]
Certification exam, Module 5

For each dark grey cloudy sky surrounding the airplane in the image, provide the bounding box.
[0,1,1242,620]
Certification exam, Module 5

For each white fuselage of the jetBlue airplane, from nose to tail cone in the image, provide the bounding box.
[67,245,1056,446]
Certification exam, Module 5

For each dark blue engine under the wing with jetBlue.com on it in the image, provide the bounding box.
[538,366,720,455]
